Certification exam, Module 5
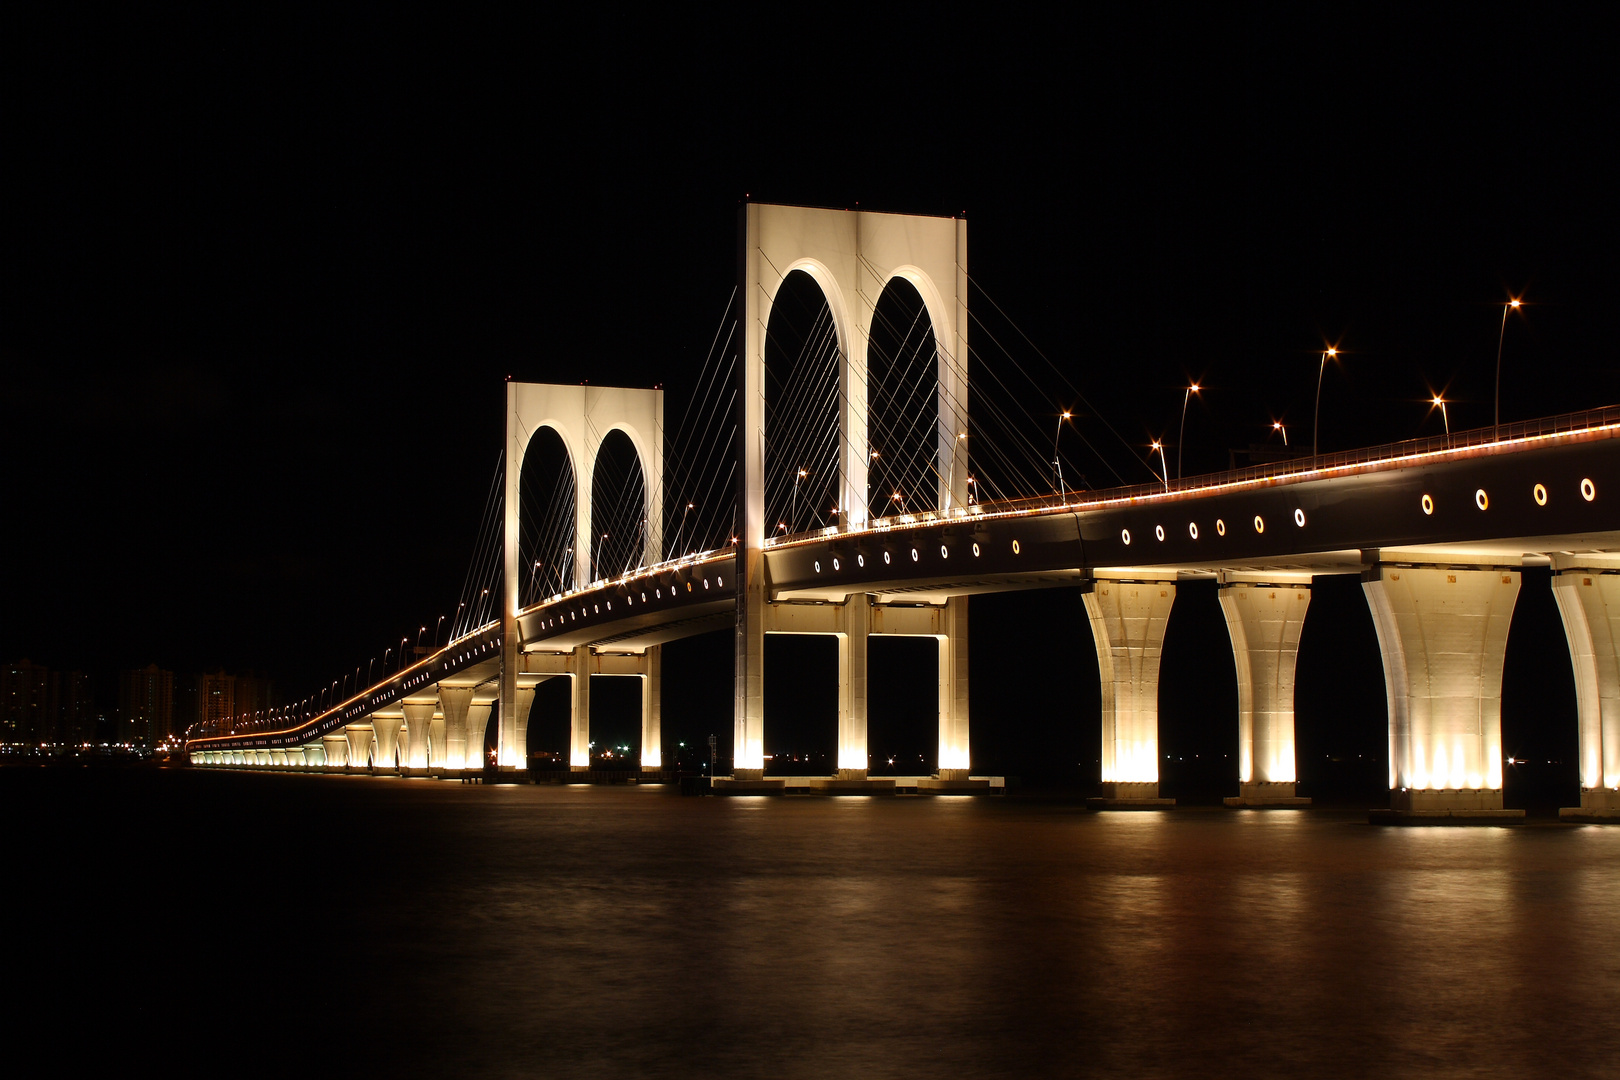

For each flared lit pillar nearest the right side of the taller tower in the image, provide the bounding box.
[1082,578,1176,805]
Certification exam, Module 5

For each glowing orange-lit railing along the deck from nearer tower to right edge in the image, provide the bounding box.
[765,405,1620,547]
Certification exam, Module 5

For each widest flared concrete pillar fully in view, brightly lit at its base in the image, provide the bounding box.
[1362,563,1520,816]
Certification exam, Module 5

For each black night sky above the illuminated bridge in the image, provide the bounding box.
[0,12,1620,790]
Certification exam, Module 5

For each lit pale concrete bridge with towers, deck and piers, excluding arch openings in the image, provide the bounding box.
[190,206,1620,819]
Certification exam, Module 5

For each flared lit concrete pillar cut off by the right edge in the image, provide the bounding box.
[1552,555,1620,819]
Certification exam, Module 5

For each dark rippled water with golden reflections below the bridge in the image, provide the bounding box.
[12,772,1620,1078]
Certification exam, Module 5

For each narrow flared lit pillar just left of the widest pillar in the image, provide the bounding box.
[1220,572,1311,806]
